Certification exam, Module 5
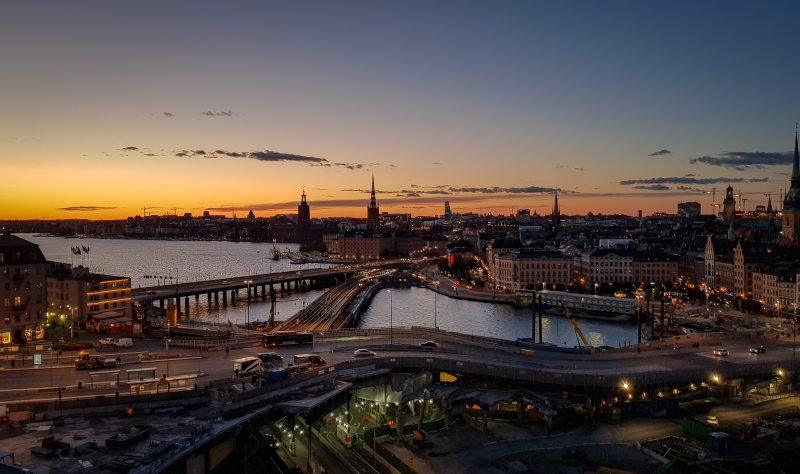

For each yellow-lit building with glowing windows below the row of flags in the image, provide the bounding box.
[47,262,132,332]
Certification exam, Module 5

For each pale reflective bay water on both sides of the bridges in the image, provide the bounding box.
[20,234,636,347]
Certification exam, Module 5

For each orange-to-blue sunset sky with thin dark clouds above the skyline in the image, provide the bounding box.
[0,0,800,219]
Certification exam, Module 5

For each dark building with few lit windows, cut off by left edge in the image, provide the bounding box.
[0,233,47,344]
